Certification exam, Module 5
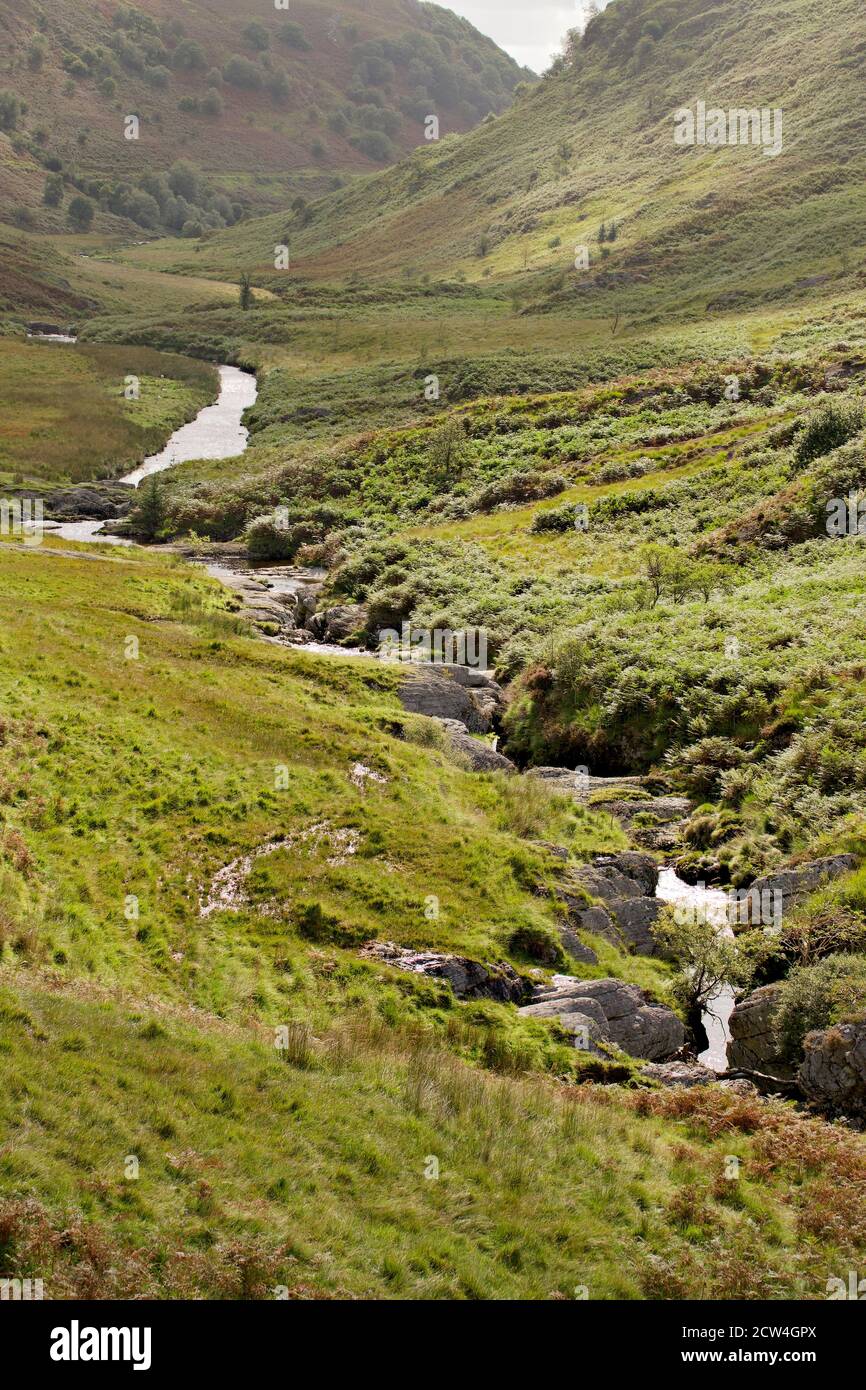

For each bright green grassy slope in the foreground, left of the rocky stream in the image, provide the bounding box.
[0,545,863,1298]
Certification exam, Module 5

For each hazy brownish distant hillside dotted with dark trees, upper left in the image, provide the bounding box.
[0,0,528,234]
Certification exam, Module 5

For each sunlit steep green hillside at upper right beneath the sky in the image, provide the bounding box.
[183,0,866,325]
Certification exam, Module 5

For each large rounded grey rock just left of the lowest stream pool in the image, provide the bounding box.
[520,974,687,1062]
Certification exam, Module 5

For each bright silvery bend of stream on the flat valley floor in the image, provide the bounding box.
[46,367,259,545]
